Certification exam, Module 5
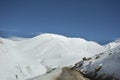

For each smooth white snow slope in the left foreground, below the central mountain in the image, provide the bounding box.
[0,39,46,80]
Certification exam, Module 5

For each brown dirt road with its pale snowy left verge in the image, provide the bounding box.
[27,67,89,80]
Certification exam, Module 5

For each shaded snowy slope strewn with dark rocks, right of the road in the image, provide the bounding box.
[78,46,120,80]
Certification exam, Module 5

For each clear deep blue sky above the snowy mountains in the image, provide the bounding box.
[0,0,120,44]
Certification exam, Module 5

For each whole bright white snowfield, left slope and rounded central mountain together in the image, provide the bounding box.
[0,33,119,80]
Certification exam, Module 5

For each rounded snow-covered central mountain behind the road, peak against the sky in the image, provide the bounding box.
[15,33,105,67]
